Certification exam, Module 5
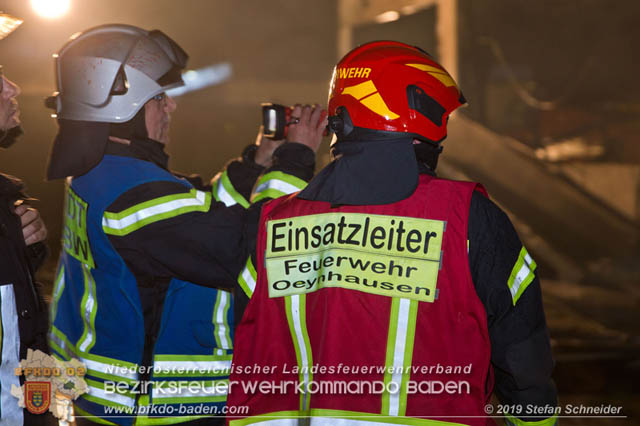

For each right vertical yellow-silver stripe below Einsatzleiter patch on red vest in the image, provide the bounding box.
[382,298,418,416]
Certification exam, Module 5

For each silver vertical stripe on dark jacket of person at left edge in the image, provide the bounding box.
[0,284,23,425]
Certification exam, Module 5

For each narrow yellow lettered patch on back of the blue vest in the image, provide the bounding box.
[62,188,95,268]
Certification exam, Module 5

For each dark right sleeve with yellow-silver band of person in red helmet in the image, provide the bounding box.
[468,193,557,426]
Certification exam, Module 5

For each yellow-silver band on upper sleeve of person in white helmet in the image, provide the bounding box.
[102,189,211,236]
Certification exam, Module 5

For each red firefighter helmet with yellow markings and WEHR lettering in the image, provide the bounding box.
[329,41,466,142]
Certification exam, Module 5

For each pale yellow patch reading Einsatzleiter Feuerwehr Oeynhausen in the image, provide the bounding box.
[265,213,444,302]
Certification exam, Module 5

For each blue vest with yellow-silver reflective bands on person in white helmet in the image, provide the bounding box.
[49,155,233,425]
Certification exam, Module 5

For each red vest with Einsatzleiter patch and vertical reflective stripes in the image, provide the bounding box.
[228,175,494,425]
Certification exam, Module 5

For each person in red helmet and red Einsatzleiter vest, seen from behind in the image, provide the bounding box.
[228,41,557,426]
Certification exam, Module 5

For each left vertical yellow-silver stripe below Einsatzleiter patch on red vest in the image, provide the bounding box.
[285,294,313,413]
